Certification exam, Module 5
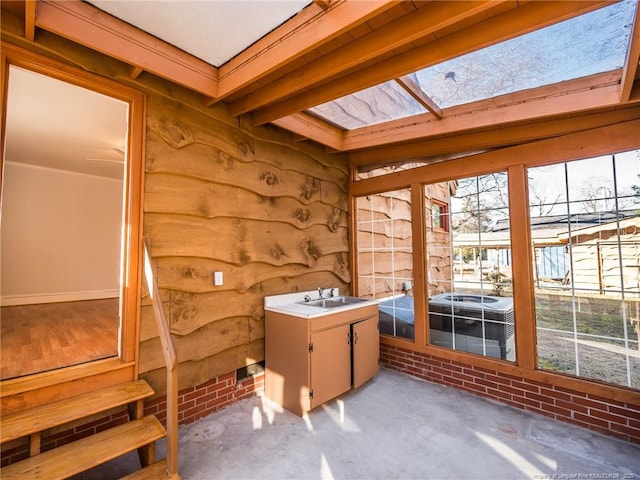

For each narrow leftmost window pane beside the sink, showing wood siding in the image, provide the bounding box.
[356,189,414,339]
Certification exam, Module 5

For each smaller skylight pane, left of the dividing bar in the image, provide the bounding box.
[308,80,427,130]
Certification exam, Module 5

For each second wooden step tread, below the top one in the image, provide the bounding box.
[0,416,166,480]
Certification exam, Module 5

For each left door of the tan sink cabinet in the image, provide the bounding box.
[309,325,351,408]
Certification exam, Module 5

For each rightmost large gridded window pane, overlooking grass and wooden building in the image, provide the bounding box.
[529,151,640,388]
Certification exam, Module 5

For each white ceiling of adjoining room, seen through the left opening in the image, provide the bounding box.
[5,66,128,178]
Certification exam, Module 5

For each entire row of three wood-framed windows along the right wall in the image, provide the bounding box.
[350,120,640,395]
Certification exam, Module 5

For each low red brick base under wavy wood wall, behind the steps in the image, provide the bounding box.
[1,372,264,466]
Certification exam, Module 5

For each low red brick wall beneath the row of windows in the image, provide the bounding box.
[380,344,640,443]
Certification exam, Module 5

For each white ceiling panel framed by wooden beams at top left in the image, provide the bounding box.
[88,0,311,67]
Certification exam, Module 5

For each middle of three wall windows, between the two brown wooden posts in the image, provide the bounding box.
[424,173,515,361]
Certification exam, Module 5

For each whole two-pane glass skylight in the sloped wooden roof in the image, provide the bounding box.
[308,0,636,130]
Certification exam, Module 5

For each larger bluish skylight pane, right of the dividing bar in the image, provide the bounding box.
[416,0,636,108]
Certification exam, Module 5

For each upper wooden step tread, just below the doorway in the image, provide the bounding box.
[0,380,154,443]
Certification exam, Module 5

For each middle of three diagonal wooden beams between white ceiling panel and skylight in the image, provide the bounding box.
[229,0,496,115]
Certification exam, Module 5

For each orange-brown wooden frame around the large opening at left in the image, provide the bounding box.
[0,42,146,411]
